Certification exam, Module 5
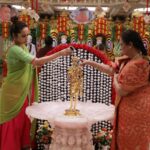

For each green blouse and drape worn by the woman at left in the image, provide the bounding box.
[0,45,38,124]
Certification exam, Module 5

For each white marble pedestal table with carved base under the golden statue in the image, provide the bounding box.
[26,102,115,150]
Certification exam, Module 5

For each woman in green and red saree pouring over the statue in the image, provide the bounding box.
[0,21,71,150]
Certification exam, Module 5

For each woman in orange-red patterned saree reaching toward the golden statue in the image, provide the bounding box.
[83,30,150,150]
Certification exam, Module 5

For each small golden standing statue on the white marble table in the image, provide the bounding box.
[65,57,83,116]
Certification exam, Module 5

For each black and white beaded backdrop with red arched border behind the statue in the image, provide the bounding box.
[38,44,112,150]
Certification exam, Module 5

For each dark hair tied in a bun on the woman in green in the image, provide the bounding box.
[10,20,27,38]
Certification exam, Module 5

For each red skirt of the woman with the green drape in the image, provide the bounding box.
[0,99,31,150]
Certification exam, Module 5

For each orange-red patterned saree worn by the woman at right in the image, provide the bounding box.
[111,59,150,150]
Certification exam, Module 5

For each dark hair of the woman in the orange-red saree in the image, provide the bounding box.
[121,29,147,56]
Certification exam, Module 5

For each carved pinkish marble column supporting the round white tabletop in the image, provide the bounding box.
[50,126,94,150]
